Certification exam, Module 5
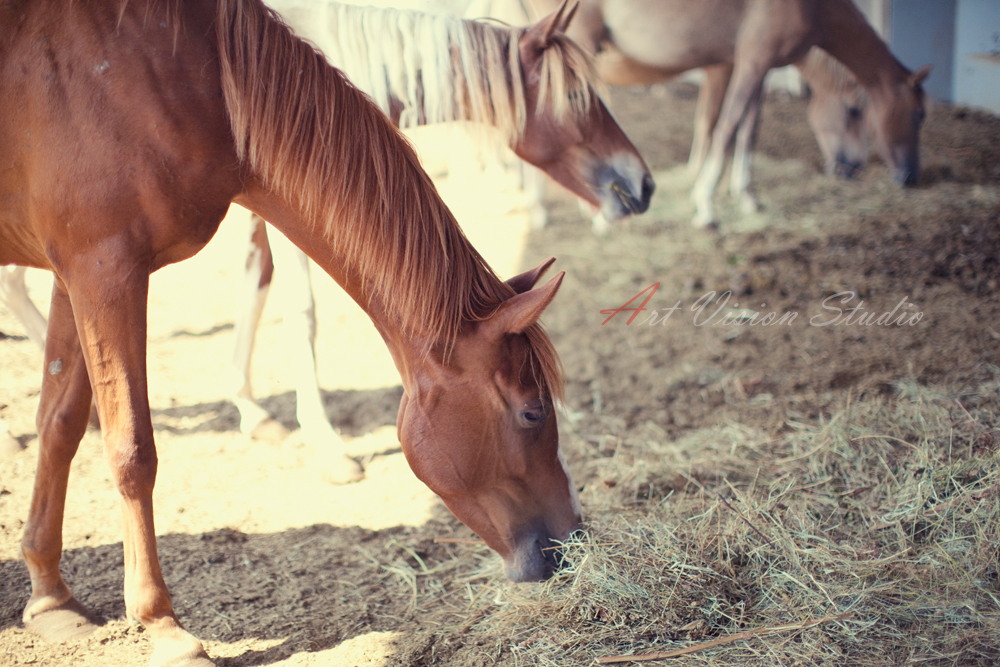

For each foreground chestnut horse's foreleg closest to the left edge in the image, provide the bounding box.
[21,280,98,641]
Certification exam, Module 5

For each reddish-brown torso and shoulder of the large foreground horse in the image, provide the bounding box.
[0,0,238,271]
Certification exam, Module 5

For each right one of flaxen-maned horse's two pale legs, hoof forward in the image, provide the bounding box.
[268,227,364,484]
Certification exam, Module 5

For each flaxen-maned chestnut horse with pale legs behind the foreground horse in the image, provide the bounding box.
[232,0,653,483]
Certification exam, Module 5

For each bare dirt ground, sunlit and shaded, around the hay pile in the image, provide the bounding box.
[0,83,1000,667]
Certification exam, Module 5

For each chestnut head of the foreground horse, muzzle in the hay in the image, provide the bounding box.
[397,260,581,581]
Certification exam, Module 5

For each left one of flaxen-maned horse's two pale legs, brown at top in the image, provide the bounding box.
[230,215,288,440]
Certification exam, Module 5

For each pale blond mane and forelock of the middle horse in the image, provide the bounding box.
[308,2,603,144]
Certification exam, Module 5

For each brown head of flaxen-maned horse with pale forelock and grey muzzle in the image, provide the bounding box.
[513,0,654,221]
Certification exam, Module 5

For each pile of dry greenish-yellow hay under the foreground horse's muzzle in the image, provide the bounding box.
[422,368,1000,666]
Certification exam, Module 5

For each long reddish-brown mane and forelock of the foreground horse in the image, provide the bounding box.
[121,0,563,400]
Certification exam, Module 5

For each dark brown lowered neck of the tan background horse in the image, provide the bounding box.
[817,0,909,94]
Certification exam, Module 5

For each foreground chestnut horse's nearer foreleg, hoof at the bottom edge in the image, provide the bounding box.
[64,264,212,667]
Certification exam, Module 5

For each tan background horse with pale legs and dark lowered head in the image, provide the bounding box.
[520,0,930,226]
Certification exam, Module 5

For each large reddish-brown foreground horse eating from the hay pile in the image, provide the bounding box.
[0,0,580,667]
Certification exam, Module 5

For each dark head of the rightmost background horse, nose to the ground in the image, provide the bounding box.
[871,65,931,185]
